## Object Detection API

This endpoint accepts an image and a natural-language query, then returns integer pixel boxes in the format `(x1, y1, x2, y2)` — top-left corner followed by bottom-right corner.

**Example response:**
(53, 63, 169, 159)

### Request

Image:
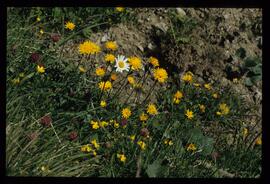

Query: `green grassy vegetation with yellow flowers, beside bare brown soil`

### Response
(6, 7, 261, 177)
